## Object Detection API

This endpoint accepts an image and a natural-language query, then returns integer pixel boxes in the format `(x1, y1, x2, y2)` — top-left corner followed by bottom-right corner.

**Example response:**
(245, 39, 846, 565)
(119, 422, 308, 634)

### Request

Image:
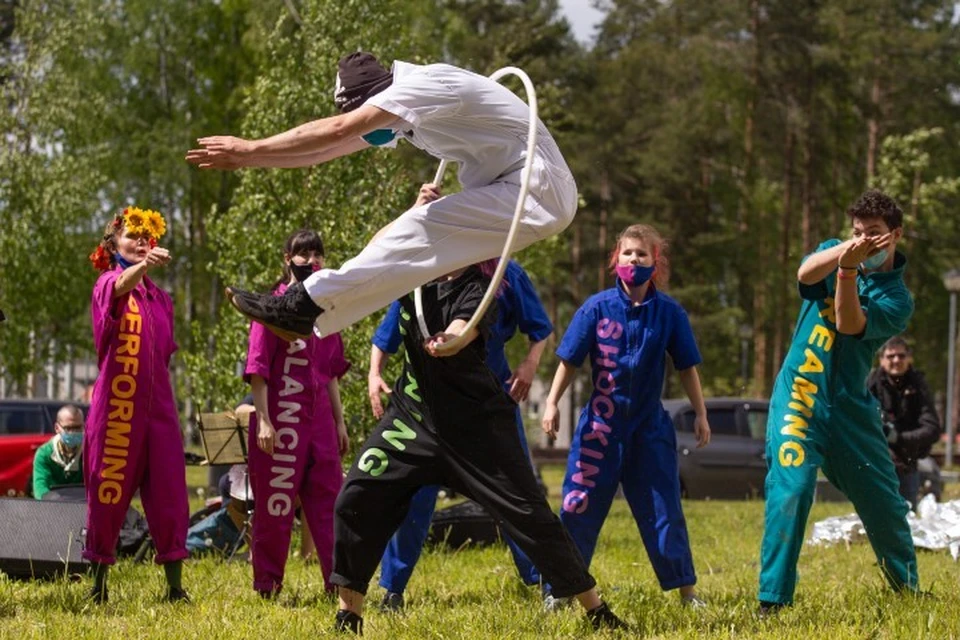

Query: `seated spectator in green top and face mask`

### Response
(33, 404, 83, 500)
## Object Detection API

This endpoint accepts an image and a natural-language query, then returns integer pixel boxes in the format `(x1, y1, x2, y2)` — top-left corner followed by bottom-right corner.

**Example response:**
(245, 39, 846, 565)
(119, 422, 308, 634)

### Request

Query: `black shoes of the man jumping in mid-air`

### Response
(227, 282, 323, 342)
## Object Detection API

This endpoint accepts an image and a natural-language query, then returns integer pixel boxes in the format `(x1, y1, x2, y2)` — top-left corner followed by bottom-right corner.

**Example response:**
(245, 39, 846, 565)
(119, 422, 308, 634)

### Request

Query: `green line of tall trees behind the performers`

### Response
(0, 0, 960, 440)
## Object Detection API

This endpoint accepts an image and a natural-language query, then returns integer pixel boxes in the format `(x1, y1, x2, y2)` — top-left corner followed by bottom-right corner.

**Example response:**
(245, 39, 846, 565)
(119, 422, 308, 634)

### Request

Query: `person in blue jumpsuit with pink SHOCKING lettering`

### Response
(543, 225, 710, 607)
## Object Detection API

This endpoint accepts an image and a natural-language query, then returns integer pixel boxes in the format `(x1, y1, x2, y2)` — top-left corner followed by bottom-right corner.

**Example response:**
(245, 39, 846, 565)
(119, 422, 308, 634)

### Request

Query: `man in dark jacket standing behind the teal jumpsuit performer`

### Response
(867, 336, 940, 508)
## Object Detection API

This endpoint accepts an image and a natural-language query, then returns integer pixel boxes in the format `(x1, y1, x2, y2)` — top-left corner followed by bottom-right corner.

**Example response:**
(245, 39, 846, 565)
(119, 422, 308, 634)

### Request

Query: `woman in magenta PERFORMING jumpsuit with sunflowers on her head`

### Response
(83, 207, 189, 603)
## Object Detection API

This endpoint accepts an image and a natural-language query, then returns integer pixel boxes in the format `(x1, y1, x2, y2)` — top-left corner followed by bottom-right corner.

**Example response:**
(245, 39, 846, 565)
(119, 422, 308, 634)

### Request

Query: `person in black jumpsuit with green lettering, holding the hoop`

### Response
(330, 265, 623, 633)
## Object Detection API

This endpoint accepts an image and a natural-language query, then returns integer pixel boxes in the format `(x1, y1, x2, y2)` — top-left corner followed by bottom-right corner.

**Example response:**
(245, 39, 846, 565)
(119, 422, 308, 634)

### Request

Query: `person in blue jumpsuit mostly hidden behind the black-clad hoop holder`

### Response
(368, 254, 553, 609)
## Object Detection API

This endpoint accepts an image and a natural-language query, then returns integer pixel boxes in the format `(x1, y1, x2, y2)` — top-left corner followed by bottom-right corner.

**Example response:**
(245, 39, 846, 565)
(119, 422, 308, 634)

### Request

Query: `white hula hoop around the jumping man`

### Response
(413, 67, 538, 354)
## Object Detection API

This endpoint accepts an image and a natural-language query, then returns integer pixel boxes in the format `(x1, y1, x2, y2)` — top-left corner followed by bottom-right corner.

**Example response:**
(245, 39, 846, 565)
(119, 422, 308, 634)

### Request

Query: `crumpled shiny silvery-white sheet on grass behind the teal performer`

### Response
(807, 495, 960, 560)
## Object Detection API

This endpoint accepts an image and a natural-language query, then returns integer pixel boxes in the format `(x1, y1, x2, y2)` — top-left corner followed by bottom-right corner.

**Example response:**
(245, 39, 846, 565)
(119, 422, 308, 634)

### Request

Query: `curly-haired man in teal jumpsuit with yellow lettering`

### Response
(759, 190, 917, 614)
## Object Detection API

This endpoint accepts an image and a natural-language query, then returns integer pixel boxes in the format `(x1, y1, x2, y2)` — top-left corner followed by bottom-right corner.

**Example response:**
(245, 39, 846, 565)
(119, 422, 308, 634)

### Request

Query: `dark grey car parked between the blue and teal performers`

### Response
(663, 398, 769, 500)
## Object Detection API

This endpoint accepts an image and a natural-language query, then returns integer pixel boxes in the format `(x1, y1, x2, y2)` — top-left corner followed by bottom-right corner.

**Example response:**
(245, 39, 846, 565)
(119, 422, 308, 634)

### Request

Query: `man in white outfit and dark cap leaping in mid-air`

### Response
(187, 52, 577, 339)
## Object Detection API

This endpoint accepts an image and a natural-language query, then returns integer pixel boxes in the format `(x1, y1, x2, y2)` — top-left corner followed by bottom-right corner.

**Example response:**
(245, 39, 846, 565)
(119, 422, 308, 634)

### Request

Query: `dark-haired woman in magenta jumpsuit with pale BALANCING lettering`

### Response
(245, 230, 350, 597)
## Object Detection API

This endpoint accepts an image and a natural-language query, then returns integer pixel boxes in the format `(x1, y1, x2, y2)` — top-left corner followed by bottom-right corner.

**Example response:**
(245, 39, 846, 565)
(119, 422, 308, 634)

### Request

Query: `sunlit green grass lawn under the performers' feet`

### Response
(0, 468, 960, 640)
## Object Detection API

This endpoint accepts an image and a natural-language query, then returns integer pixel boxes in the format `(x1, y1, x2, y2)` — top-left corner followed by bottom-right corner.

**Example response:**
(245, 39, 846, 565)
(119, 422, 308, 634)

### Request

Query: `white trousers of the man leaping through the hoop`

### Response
(304, 156, 577, 336)
